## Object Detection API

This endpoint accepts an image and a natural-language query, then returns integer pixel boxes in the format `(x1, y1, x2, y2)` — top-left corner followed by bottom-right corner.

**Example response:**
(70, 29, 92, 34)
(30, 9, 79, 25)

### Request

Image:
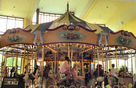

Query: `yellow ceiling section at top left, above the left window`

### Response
(0, 0, 40, 18)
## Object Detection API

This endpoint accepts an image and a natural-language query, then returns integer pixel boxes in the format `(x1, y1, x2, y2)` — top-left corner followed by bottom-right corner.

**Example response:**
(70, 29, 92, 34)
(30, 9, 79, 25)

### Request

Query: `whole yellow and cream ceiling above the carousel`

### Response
(0, 0, 136, 31)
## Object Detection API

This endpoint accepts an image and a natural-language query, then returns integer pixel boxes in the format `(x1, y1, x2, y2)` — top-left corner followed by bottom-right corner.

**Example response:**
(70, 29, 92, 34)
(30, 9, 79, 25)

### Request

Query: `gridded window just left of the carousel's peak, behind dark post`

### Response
(32, 12, 61, 24)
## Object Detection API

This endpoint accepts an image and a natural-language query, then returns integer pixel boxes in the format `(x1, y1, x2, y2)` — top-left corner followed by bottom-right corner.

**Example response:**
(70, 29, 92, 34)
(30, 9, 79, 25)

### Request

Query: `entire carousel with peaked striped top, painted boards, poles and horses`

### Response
(0, 2, 136, 88)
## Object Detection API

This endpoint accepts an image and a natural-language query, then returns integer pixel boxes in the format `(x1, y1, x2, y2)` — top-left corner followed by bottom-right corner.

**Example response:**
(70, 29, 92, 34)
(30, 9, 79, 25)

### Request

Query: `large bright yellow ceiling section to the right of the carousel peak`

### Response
(83, 0, 136, 31)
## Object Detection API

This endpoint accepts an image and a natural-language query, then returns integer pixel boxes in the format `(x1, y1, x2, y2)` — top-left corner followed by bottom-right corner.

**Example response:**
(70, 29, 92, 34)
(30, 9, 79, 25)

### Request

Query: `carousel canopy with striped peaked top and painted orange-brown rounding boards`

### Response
(0, 9, 136, 48)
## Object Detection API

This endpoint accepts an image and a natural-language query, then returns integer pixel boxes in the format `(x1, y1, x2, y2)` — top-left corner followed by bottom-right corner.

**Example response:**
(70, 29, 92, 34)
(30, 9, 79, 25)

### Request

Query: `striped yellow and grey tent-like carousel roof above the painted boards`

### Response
(25, 7, 112, 33)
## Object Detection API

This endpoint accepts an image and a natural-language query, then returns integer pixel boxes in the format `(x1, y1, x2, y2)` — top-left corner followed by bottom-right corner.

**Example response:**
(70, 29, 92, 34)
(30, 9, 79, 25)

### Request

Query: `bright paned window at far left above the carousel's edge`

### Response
(0, 16, 24, 34)
